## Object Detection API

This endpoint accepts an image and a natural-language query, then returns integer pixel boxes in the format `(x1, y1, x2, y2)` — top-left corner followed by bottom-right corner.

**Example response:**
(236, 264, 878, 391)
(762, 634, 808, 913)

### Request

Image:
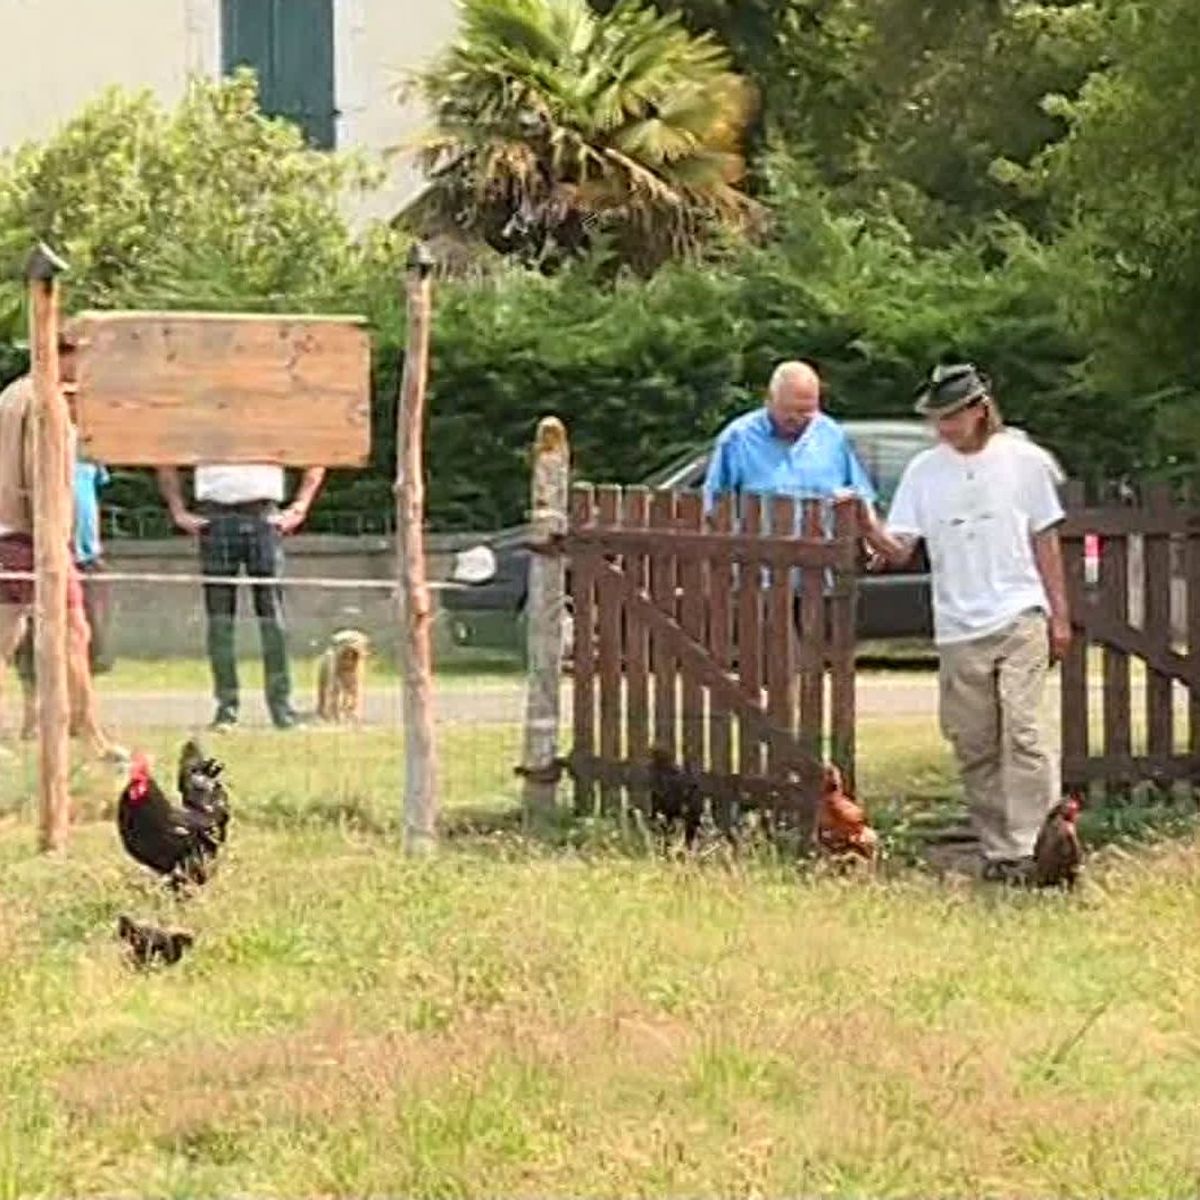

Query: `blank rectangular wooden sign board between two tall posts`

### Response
(71, 312, 371, 467)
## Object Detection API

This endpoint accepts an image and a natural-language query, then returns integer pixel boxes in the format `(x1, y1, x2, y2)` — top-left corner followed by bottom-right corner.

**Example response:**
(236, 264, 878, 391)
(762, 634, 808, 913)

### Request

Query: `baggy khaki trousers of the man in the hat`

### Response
(938, 611, 1057, 860)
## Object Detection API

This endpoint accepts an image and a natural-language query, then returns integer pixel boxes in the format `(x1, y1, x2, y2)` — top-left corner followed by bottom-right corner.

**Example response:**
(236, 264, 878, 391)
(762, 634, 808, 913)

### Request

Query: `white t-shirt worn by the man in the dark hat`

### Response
(888, 434, 1063, 646)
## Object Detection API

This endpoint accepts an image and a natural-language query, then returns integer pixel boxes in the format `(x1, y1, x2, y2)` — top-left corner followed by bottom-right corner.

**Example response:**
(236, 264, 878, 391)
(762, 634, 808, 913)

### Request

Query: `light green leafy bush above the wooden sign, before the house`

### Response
(0, 73, 396, 331)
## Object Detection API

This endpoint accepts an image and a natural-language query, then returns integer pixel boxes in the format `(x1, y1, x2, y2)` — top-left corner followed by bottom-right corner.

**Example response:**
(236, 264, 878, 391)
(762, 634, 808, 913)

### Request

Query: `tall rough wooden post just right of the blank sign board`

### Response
(395, 244, 437, 854)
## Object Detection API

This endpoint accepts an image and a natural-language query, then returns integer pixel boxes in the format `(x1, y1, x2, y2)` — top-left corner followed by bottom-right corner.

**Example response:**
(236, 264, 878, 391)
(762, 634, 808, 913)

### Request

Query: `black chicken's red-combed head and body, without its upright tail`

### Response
(116, 755, 218, 889)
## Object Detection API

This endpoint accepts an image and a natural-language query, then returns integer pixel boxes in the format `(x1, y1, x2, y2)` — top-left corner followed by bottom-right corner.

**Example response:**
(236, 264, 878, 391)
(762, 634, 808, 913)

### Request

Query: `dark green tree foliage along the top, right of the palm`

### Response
(614, 0, 1103, 244)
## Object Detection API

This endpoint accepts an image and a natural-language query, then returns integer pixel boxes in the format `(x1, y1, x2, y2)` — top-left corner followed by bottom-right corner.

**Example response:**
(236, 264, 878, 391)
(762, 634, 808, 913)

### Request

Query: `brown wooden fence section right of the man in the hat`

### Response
(1062, 484, 1200, 790)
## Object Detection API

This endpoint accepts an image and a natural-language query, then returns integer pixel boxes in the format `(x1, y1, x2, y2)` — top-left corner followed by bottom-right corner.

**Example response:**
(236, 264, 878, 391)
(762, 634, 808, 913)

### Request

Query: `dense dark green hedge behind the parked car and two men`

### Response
(0, 236, 1153, 529)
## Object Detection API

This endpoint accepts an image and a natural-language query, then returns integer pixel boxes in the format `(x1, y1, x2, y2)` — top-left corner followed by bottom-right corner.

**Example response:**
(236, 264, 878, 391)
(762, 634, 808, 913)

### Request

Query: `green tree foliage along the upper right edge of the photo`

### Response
(1039, 0, 1200, 457)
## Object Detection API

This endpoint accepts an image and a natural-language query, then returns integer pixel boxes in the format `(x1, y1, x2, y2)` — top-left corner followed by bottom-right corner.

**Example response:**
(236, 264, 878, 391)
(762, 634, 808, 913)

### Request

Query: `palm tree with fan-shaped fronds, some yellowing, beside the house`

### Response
(403, 0, 755, 270)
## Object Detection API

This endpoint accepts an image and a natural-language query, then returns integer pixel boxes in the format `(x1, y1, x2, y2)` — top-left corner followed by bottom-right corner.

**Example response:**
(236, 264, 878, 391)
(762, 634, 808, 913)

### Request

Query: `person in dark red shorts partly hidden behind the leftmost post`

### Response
(0, 336, 127, 763)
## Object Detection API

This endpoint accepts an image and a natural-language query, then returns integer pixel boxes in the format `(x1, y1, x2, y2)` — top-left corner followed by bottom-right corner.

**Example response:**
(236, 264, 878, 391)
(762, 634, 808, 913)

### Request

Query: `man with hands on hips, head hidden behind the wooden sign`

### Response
(158, 463, 325, 730)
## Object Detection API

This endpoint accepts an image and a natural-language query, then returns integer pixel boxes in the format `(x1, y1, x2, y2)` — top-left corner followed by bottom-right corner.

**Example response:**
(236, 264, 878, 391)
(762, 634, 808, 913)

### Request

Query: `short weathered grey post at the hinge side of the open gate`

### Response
(520, 416, 571, 816)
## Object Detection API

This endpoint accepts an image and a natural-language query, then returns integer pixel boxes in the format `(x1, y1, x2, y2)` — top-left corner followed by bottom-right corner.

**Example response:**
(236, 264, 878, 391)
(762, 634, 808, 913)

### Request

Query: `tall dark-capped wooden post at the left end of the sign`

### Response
(28, 245, 72, 851)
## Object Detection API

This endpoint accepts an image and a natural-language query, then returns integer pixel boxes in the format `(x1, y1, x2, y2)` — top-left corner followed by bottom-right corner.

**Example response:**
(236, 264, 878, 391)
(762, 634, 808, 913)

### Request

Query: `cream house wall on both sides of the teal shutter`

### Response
(0, 0, 456, 216)
